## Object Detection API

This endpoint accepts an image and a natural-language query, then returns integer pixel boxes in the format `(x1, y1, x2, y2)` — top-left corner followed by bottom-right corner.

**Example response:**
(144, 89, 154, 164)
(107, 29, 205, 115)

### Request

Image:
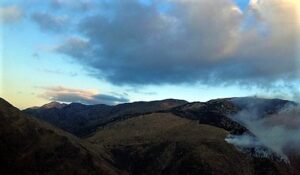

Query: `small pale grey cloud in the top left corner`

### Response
(0, 6, 22, 24)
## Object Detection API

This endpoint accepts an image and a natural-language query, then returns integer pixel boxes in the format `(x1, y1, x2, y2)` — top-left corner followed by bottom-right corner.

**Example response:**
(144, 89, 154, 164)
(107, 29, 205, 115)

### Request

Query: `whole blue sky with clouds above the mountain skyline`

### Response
(0, 0, 300, 109)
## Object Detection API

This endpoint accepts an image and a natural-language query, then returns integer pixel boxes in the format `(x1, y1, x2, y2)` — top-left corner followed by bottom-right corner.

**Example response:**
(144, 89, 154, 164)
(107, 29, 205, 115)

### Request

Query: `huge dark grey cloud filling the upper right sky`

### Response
(39, 0, 300, 87)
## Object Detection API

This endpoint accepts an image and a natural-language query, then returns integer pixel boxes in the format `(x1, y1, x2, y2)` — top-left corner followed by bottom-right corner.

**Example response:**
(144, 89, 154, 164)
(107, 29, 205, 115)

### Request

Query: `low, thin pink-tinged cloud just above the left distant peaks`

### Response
(41, 86, 129, 105)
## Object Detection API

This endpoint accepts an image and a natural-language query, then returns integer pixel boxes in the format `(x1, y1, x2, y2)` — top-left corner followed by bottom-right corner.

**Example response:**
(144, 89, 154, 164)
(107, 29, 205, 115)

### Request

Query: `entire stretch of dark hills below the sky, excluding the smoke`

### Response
(0, 97, 300, 175)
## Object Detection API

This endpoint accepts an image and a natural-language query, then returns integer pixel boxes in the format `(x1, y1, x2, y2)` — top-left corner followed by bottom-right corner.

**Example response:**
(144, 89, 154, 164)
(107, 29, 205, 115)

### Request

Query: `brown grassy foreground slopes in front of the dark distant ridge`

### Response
(0, 98, 291, 175)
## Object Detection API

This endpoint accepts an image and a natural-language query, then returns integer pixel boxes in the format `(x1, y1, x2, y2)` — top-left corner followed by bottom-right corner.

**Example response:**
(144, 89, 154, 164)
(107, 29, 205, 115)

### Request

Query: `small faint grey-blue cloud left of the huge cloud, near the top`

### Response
(31, 12, 70, 32)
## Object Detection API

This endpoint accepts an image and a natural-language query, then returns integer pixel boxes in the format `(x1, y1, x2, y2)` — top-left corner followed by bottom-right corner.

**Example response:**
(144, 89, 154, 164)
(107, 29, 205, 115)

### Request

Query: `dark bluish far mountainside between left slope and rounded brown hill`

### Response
(24, 99, 187, 136)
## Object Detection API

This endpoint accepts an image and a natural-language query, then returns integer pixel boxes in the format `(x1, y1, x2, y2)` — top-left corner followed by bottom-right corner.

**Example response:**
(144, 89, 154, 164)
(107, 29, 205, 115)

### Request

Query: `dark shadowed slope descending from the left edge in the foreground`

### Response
(0, 98, 118, 175)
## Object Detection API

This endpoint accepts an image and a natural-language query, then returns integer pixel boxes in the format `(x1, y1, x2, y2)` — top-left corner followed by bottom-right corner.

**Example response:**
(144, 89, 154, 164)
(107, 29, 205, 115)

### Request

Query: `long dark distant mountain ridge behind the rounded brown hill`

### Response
(23, 97, 296, 137)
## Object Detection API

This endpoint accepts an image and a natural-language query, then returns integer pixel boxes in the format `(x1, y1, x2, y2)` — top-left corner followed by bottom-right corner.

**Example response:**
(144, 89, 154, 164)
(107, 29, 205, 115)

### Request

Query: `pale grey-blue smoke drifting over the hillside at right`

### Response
(226, 100, 300, 161)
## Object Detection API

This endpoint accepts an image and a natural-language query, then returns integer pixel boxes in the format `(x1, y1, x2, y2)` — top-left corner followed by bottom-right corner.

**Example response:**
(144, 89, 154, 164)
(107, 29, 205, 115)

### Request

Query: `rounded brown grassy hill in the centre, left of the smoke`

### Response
(88, 113, 292, 175)
